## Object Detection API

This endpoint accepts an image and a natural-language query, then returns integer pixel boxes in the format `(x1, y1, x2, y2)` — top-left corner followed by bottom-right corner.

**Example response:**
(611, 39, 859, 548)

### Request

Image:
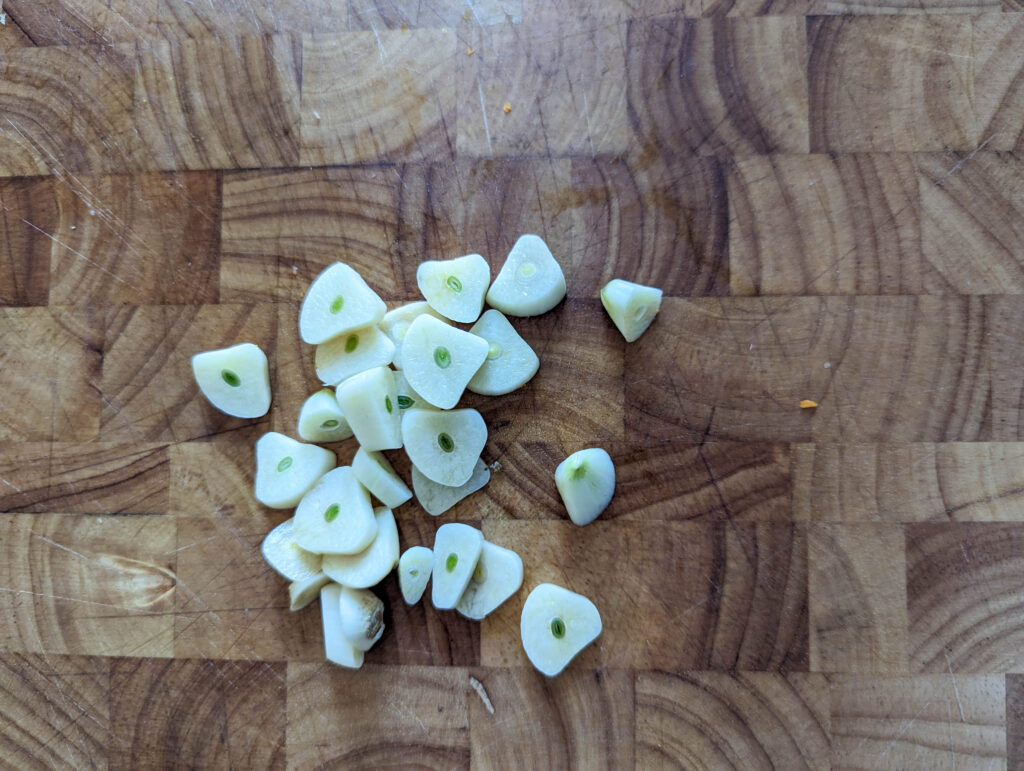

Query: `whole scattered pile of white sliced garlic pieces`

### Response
(193, 234, 662, 676)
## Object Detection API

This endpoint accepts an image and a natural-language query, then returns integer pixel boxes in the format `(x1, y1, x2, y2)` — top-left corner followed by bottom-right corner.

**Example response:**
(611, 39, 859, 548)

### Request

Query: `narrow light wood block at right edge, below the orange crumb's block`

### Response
(793, 442, 1024, 523)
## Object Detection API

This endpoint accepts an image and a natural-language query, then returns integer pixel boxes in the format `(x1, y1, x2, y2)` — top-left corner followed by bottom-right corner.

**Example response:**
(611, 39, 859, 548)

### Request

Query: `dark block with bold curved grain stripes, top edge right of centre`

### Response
(626, 16, 808, 158)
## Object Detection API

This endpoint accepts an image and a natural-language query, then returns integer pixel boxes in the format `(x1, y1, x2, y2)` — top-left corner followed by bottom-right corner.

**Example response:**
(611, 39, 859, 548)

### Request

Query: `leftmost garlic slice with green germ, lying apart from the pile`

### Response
(191, 343, 270, 418)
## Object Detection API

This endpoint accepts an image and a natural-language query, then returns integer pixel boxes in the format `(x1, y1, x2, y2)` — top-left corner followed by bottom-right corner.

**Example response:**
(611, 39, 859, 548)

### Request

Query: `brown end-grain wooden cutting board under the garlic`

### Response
(0, 0, 1024, 769)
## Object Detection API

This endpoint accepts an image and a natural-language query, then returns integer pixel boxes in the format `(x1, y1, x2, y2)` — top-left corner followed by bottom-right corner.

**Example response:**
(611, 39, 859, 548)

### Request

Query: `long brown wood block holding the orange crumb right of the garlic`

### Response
(625, 297, 995, 441)
